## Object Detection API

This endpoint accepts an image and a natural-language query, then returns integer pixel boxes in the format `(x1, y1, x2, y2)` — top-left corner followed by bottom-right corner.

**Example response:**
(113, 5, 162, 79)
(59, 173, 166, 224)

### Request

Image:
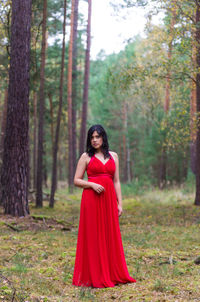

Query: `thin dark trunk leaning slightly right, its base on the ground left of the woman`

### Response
(49, 0, 67, 208)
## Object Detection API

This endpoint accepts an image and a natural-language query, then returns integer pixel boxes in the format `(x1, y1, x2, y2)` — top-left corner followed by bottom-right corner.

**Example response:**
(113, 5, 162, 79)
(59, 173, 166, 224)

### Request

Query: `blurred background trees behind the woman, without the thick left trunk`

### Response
(0, 0, 200, 214)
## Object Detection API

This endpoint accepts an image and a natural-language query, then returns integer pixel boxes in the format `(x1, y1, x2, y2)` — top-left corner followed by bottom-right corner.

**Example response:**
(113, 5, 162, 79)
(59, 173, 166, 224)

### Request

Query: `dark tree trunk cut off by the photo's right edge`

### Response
(194, 1, 200, 206)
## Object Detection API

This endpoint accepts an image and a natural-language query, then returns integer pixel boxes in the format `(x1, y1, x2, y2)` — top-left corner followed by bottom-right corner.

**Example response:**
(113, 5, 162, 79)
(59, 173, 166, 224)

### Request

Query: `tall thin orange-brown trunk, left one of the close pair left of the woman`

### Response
(67, 0, 75, 192)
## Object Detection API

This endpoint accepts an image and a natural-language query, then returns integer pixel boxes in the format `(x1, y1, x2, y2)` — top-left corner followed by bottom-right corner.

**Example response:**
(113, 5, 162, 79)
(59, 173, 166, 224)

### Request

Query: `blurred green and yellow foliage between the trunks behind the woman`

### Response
(0, 0, 197, 186)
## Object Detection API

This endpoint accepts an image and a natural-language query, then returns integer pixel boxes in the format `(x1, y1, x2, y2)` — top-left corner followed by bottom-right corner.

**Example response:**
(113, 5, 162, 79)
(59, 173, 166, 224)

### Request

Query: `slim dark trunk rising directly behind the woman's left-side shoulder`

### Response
(79, 0, 92, 155)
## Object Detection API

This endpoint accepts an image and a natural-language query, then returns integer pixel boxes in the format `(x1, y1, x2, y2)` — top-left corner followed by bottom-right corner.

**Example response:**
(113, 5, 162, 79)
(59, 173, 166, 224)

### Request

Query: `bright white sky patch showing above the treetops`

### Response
(79, 0, 155, 59)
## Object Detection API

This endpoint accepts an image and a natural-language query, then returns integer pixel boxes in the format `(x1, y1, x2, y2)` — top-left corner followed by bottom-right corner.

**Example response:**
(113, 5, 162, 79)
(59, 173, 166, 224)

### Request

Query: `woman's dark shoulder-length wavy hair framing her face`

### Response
(86, 125, 110, 158)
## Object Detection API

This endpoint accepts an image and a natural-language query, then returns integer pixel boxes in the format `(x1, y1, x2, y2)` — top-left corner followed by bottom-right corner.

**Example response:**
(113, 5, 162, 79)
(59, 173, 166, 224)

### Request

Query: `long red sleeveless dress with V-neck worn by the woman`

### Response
(73, 156, 136, 287)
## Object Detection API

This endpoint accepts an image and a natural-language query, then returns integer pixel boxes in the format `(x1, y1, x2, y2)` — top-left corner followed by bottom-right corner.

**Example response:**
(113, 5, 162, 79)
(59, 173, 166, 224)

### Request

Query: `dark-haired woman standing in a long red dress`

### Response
(73, 125, 136, 287)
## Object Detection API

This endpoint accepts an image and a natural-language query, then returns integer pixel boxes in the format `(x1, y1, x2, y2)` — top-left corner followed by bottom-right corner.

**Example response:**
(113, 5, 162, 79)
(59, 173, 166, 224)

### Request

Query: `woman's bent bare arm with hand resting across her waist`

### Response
(74, 153, 104, 193)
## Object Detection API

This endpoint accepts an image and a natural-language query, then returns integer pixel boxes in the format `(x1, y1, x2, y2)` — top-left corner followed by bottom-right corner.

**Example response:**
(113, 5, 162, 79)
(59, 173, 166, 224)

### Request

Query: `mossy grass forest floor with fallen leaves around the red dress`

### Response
(0, 184, 200, 302)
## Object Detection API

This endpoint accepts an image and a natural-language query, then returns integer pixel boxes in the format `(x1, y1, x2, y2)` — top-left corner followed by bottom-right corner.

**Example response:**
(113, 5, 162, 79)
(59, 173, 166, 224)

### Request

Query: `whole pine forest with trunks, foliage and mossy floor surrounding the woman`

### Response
(0, 0, 200, 302)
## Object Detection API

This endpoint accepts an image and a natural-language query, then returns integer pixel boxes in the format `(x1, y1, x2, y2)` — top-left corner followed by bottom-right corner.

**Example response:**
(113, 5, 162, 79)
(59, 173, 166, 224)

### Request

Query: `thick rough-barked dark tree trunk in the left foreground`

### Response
(1, 0, 31, 216)
